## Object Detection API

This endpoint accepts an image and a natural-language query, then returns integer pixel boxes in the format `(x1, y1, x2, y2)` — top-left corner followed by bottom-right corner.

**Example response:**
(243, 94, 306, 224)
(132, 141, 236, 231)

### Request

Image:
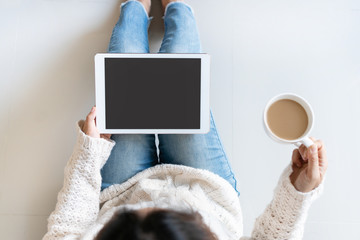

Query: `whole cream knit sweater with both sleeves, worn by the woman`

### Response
(43, 121, 323, 240)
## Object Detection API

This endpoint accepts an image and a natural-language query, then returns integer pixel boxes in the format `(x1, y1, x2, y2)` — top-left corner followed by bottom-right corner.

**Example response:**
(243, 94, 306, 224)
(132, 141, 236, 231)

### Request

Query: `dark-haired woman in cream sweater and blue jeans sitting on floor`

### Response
(44, 0, 327, 240)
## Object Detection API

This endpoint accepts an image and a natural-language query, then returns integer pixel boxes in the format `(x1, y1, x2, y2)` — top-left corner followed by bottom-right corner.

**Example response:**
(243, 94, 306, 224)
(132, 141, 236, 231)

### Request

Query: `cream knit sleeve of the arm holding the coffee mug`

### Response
(241, 166, 323, 240)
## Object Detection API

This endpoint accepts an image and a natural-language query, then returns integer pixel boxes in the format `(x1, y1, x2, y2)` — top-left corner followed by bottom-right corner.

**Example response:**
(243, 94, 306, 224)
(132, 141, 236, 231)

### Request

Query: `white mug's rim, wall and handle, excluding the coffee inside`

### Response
(264, 93, 314, 147)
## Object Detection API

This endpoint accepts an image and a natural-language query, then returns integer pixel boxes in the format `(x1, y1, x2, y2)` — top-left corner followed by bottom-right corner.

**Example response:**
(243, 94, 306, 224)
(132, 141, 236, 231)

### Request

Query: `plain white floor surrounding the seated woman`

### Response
(0, 0, 360, 240)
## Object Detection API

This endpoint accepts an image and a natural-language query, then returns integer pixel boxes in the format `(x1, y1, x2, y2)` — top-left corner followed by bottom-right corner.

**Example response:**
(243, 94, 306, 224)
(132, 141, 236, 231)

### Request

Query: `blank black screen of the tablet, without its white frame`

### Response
(105, 58, 201, 129)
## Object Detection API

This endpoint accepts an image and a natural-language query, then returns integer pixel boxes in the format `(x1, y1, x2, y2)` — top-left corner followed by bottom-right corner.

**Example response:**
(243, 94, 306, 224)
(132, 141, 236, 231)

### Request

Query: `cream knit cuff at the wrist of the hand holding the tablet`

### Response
(76, 120, 115, 166)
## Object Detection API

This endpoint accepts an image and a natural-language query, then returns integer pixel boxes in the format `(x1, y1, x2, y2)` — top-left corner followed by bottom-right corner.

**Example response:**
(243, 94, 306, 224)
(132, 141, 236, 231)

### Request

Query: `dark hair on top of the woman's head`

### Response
(96, 210, 217, 240)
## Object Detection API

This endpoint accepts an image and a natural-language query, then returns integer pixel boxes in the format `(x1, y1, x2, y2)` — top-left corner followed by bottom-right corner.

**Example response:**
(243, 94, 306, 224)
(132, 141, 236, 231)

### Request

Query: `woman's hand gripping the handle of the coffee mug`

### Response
(290, 138, 328, 192)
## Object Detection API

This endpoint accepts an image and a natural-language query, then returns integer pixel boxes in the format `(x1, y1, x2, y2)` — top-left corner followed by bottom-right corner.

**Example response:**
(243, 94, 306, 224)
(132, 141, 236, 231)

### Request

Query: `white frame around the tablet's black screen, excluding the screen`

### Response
(95, 53, 210, 134)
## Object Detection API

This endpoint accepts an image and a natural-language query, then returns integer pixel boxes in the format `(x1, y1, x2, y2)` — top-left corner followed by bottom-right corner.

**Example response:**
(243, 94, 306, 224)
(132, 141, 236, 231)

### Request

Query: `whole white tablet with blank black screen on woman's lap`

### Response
(95, 53, 210, 134)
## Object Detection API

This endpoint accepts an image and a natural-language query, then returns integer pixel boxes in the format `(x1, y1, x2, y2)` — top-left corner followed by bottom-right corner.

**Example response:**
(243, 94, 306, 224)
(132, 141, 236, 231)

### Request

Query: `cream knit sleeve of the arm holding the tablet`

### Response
(43, 121, 115, 240)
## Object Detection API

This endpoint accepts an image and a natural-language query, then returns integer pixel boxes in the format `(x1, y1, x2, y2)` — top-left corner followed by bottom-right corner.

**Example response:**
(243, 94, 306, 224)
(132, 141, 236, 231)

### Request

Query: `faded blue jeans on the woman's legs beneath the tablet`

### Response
(101, 0, 239, 194)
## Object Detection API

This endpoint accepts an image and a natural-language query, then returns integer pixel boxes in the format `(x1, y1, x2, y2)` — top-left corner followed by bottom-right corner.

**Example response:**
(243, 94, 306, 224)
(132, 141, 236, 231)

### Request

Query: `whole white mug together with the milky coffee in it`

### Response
(264, 93, 314, 147)
